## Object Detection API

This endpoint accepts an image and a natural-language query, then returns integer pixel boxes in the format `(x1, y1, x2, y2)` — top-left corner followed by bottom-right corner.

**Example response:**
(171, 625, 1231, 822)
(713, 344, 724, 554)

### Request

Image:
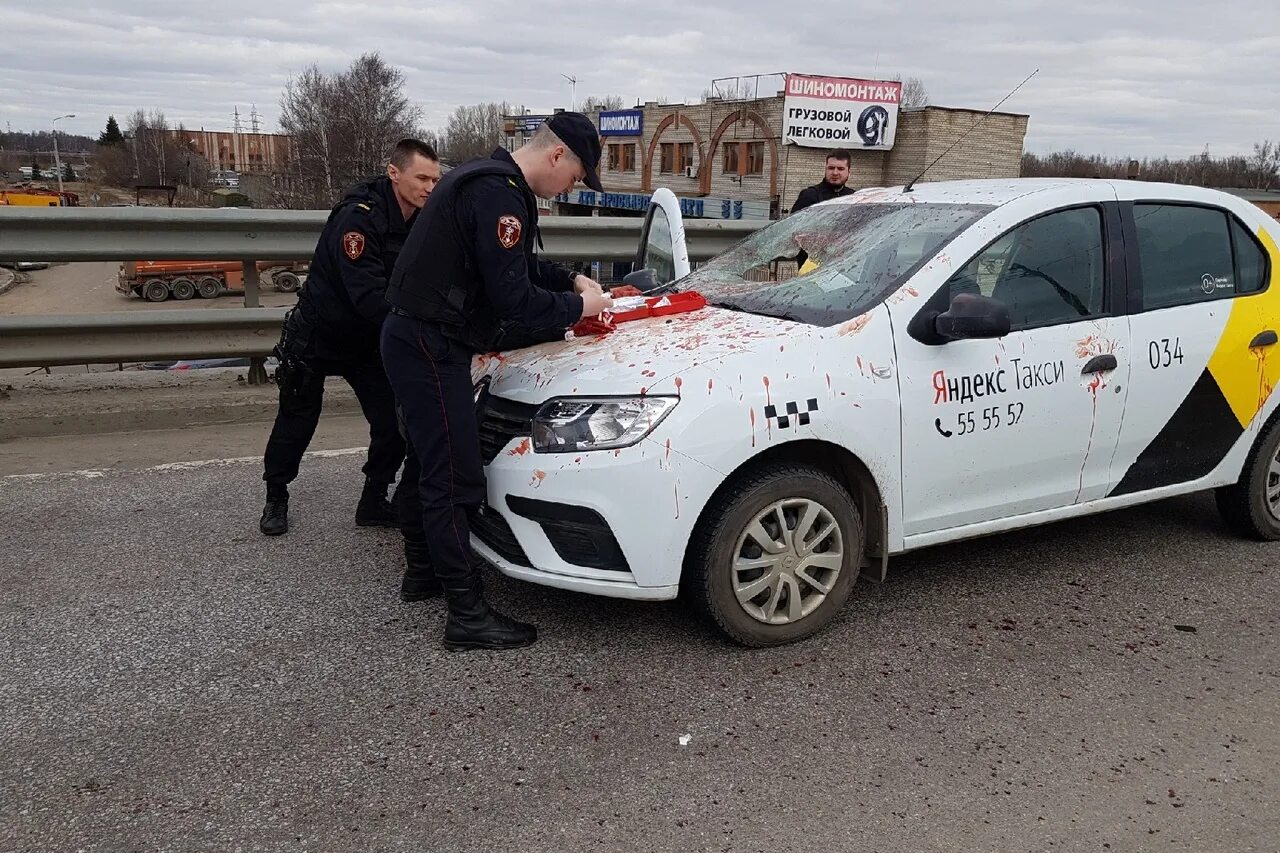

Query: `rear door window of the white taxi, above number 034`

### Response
(1133, 204, 1248, 310)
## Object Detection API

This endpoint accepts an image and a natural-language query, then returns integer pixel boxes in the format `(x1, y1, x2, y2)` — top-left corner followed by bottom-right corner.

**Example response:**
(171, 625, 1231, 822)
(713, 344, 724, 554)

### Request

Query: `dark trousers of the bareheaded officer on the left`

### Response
(262, 356, 404, 485)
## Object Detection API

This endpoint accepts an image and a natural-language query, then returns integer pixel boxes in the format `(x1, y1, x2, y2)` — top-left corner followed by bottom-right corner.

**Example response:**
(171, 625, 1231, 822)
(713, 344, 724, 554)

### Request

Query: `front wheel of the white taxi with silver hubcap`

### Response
(682, 462, 864, 648)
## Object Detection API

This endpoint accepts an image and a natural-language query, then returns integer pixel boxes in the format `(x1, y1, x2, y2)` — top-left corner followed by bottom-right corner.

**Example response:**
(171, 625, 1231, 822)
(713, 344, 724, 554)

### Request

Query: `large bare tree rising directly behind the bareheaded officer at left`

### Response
(273, 54, 422, 207)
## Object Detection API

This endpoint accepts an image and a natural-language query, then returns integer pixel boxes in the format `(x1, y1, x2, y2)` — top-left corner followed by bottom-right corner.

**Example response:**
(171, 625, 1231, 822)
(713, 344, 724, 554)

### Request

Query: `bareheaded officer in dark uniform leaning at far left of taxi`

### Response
(259, 140, 440, 535)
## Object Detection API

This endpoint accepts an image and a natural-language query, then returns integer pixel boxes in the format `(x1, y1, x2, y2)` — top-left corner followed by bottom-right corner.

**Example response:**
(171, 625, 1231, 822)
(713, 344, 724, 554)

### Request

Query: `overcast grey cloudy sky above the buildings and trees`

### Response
(0, 0, 1280, 156)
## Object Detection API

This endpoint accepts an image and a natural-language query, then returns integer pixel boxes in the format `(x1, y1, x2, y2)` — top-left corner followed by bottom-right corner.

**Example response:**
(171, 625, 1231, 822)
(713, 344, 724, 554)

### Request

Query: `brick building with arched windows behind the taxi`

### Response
(547, 85, 1028, 219)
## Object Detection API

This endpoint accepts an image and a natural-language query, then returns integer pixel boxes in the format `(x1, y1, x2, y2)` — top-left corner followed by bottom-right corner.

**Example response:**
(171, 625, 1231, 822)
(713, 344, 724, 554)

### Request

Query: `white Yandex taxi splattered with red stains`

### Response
(472, 179, 1280, 646)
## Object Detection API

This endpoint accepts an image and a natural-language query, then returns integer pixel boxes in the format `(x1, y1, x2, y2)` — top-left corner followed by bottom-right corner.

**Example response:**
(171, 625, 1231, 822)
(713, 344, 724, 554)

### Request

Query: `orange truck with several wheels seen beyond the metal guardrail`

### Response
(115, 261, 307, 302)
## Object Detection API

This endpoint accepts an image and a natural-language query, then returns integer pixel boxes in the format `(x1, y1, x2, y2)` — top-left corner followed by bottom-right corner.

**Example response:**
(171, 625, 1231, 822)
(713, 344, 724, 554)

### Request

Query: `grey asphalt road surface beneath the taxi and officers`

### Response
(0, 440, 1280, 853)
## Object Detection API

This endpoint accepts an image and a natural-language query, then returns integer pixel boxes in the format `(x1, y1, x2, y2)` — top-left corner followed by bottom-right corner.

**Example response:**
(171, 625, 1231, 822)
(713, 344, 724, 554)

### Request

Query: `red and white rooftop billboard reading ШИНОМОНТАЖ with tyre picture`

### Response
(782, 74, 902, 151)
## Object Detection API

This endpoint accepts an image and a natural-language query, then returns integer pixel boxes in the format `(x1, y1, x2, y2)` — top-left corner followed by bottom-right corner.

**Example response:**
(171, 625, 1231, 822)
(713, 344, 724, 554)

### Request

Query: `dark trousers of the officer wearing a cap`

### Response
(383, 311, 485, 587)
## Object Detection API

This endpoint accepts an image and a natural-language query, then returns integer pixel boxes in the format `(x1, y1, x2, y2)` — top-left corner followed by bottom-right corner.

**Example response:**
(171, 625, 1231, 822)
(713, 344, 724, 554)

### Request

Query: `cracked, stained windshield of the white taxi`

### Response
(676, 202, 993, 325)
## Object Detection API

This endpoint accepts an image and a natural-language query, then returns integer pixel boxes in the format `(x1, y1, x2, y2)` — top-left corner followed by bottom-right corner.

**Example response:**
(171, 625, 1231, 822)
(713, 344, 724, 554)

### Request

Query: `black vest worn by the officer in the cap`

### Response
(387, 158, 541, 352)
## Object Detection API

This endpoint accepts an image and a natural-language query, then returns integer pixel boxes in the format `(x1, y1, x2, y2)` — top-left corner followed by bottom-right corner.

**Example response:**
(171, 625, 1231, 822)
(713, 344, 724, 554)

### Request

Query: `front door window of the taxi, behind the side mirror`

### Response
(948, 207, 1106, 329)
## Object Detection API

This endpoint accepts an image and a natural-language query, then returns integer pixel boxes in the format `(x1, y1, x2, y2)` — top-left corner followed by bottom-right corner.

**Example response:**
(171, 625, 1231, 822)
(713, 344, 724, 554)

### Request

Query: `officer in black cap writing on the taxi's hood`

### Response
(383, 113, 611, 649)
